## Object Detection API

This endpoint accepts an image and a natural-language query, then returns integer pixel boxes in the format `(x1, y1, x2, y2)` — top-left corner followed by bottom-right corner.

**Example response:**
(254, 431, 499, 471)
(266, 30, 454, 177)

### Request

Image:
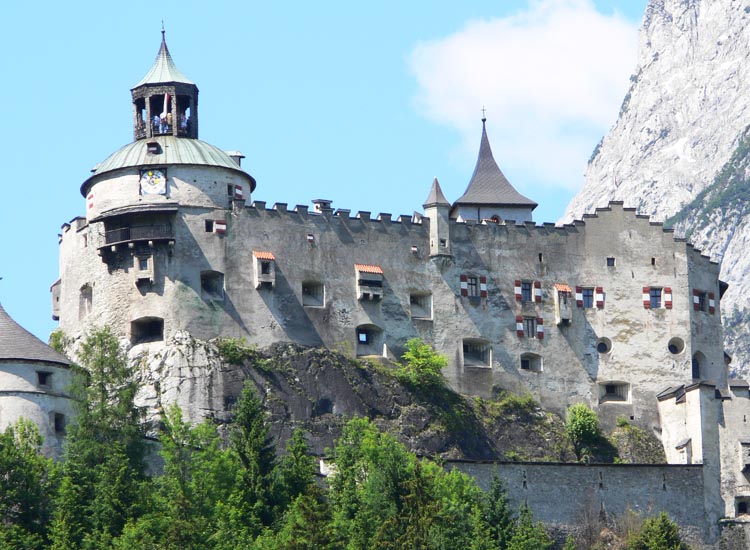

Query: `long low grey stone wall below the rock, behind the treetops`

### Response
(446, 461, 718, 548)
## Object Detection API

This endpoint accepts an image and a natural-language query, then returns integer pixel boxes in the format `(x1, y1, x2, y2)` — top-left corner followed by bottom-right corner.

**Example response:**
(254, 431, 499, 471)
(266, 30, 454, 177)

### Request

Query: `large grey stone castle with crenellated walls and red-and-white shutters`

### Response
(0, 32, 750, 538)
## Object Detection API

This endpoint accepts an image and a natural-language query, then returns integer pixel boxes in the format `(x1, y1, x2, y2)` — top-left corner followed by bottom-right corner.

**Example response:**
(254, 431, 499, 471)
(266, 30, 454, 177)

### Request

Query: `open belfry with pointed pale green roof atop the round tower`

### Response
(130, 29, 198, 141)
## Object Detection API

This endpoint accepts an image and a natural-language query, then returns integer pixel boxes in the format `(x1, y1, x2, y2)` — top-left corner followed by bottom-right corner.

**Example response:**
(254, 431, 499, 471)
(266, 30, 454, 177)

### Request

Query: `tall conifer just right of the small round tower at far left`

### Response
(51, 328, 146, 548)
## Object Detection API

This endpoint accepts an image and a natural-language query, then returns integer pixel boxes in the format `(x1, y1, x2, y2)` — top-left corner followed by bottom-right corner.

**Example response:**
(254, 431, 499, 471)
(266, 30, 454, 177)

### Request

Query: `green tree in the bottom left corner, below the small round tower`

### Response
(0, 419, 57, 548)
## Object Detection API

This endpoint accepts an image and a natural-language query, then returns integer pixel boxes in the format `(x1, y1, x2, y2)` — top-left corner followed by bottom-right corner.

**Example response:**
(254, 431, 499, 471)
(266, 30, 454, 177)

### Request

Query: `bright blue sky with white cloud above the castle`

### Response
(0, 0, 647, 340)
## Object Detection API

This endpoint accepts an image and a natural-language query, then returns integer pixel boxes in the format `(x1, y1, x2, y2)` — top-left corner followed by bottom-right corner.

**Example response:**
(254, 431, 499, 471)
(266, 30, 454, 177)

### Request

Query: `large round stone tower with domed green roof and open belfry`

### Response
(52, 31, 255, 344)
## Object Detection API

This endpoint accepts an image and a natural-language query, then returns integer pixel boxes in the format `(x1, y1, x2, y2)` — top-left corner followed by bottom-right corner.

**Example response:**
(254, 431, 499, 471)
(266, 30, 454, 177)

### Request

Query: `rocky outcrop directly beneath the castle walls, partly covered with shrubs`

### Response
(129, 331, 575, 461)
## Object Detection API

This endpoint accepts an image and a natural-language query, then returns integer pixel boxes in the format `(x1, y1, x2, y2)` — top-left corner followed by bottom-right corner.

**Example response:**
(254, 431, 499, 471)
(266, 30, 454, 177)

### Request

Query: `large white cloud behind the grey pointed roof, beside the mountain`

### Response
(409, 0, 638, 189)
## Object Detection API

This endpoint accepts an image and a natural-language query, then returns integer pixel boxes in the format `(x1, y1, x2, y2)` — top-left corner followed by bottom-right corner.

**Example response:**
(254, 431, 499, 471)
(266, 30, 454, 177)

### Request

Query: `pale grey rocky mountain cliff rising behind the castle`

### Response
(564, 0, 750, 376)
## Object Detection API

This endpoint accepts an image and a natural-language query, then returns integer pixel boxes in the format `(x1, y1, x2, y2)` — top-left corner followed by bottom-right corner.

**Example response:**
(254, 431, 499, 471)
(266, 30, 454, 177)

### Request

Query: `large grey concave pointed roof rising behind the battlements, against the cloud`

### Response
(453, 120, 537, 210)
